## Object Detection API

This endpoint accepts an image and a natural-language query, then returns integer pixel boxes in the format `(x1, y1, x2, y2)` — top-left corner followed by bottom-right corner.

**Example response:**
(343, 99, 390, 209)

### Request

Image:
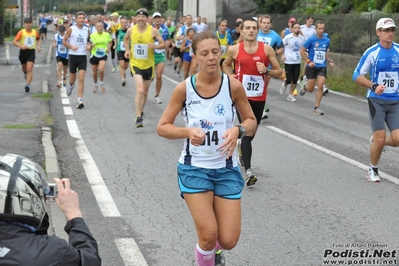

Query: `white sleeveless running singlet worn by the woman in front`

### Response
(179, 74, 237, 169)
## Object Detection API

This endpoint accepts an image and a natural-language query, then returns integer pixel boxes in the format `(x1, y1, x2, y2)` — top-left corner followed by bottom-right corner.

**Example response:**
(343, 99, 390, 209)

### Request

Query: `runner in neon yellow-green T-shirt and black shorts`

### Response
(90, 21, 112, 93)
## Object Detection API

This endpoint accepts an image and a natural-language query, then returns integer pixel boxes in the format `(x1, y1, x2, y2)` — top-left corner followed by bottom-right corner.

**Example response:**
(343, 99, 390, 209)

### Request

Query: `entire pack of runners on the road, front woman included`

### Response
(10, 8, 399, 266)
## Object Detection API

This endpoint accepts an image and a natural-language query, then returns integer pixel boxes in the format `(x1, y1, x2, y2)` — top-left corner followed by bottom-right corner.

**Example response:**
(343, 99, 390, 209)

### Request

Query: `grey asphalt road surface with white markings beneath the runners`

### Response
(49, 54, 399, 266)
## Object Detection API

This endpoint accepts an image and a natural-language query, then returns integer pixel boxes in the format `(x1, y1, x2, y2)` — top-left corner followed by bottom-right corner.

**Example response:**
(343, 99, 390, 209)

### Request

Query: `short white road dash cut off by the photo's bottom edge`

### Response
(115, 238, 148, 266)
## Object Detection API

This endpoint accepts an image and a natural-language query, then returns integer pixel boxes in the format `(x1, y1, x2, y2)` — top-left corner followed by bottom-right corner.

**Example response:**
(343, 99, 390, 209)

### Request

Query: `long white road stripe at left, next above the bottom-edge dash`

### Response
(67, 120, 121, 217)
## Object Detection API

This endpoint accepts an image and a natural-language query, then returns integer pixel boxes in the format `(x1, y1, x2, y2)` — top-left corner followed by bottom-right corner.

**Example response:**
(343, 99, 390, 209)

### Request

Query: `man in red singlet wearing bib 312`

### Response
(222, 19, 283, 186)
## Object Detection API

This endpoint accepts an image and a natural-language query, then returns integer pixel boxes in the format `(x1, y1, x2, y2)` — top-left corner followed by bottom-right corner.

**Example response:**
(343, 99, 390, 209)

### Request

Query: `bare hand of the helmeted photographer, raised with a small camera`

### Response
(54, 178, 82, 221)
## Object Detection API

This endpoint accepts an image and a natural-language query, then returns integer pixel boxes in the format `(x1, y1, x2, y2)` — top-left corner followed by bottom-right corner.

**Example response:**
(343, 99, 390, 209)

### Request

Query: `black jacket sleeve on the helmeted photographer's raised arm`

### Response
(60, 218, 101, 266)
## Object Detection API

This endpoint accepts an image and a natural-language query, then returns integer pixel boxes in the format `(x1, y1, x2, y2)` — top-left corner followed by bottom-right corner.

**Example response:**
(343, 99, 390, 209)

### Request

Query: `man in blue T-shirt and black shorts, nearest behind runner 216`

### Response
(299, 20, 334, 115)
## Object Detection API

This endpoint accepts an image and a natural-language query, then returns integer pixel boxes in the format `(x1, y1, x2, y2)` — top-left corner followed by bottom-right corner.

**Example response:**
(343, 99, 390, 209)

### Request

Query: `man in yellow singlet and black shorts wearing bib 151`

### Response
(123, 8, 166, 128)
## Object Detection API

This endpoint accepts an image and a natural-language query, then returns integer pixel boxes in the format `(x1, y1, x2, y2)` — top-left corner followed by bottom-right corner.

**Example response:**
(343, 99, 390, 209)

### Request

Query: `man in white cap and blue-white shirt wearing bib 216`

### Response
(352, 18, 399, 182)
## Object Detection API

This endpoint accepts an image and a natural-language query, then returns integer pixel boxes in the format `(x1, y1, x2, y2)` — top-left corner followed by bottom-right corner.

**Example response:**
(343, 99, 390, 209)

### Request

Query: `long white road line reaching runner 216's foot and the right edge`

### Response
(265, 126, 399, 185)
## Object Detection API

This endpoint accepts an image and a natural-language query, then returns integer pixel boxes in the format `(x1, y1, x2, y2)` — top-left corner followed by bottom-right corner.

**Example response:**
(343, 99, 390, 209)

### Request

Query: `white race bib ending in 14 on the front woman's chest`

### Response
(190, 116, 226, 156)
